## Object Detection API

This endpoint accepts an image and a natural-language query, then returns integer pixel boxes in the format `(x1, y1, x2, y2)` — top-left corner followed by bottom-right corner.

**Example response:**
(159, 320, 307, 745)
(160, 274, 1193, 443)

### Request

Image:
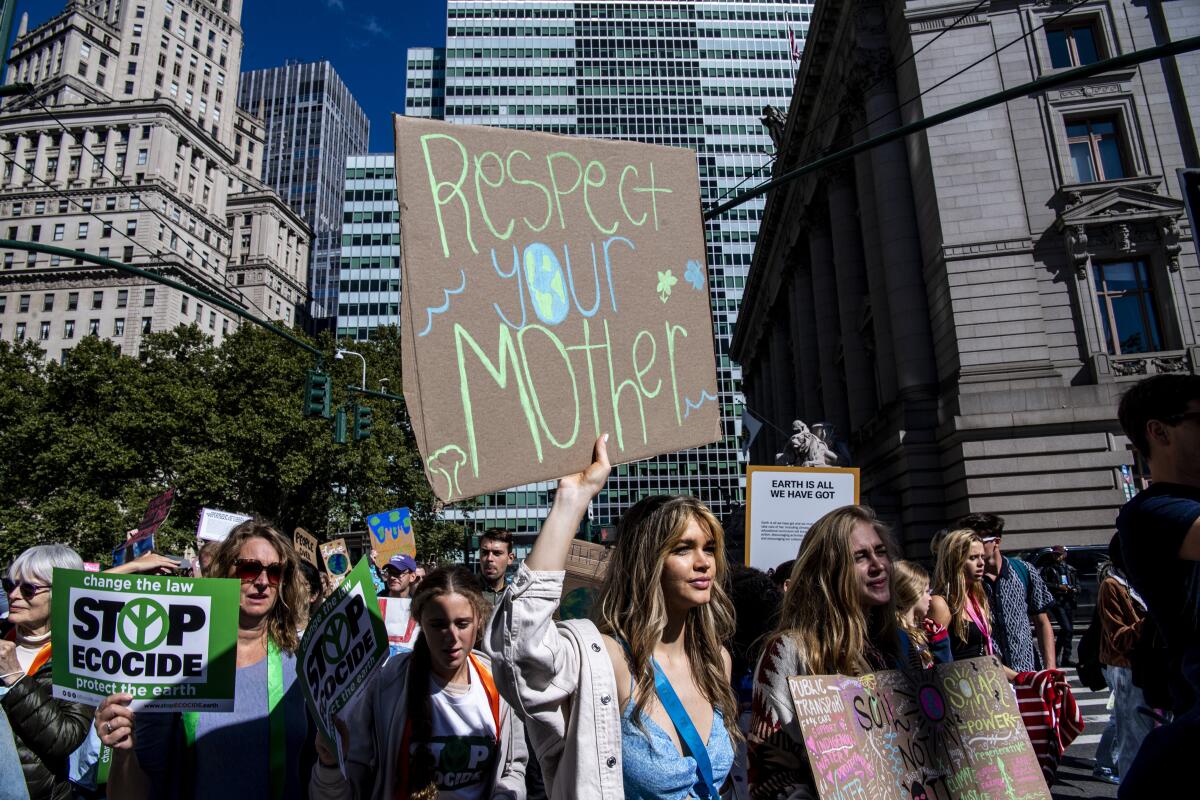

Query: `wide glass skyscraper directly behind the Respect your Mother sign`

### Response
(393, 0, 812, 530)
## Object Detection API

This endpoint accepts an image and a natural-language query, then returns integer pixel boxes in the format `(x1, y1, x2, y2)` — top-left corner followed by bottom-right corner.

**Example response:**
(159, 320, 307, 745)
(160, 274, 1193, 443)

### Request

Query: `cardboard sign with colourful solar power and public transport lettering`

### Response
(788, 656, 1050, 800)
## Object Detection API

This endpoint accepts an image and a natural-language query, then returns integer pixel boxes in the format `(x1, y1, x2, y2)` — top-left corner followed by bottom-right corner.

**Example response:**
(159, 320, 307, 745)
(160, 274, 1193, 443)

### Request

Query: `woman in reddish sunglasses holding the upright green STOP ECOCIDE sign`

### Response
(96, 518, 310, 800)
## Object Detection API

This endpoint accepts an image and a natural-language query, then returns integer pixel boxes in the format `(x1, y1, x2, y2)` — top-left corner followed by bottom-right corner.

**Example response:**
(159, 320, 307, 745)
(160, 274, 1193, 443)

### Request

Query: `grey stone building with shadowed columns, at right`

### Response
(732, 0, 1200, 555)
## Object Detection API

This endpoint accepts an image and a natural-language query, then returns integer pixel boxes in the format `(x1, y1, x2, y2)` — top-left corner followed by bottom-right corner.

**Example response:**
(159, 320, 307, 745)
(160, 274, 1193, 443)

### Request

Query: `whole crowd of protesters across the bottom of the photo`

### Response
(0, 377, 1200, 800)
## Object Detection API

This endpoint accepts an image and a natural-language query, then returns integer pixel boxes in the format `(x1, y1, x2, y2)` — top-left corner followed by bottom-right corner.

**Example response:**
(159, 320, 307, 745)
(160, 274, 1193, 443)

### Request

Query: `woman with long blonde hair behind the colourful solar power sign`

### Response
(749, 505, 912, 800)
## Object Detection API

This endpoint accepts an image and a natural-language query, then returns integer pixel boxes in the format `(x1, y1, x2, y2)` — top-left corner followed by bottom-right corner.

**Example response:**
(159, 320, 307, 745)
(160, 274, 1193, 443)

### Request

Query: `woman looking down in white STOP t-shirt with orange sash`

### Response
(310, 566, 526, 800)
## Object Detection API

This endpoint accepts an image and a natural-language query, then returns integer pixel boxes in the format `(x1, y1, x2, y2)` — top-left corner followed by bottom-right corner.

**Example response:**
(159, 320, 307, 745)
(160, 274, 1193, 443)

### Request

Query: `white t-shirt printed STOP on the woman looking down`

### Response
(414, 664, 498, 800)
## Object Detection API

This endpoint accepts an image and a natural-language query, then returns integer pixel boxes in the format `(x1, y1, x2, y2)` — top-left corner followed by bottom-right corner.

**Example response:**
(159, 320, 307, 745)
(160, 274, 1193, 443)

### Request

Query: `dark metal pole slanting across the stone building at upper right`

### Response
(704, 36, 1200, 222)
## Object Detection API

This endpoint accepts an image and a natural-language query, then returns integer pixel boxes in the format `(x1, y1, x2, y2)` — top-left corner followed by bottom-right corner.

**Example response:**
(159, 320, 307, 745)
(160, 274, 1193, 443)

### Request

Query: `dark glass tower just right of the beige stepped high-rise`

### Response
(238, 61, 371, 329)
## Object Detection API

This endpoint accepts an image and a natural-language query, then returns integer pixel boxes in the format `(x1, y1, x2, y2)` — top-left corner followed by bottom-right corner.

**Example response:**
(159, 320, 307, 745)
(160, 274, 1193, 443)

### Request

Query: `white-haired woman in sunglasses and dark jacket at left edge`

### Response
(0, 545, 91, 800)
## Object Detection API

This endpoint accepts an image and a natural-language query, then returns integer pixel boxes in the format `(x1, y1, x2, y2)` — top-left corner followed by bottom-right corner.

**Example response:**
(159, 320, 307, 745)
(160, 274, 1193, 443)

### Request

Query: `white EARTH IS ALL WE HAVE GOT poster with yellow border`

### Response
(746, 465, 858, 571)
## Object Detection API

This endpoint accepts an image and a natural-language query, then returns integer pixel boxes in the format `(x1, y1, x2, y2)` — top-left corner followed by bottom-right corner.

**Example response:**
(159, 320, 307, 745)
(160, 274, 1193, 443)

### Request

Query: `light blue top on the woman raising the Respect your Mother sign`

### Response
(620, 697, 733, 800)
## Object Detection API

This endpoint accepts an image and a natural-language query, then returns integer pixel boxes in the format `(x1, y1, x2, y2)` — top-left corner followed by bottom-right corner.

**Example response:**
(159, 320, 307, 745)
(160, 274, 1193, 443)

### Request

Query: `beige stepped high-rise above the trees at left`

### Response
(0, 0, 311, 359)
